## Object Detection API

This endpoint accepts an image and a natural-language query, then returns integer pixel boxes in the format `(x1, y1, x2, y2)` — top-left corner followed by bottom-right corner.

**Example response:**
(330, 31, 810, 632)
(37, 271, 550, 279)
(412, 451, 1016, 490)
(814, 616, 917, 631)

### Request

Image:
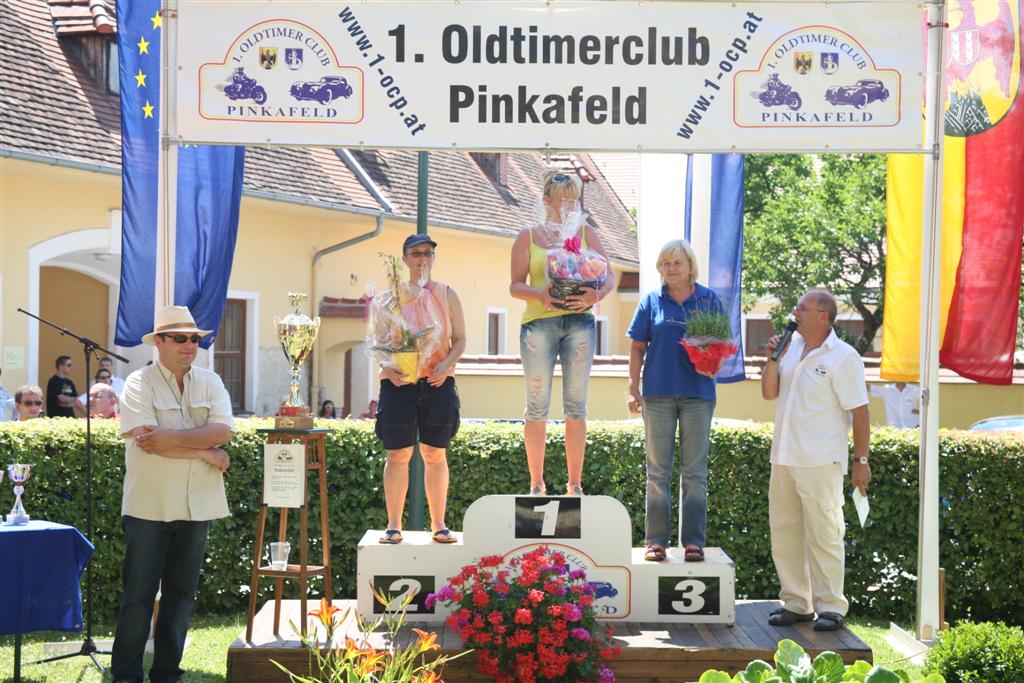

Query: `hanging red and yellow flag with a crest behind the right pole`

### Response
(881, 0, 1024, 384)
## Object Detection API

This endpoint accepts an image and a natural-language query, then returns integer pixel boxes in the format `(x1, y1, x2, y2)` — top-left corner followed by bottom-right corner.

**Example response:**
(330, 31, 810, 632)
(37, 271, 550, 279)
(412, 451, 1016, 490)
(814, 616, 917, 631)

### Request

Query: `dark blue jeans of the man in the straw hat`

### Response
(111, 516, 210, 683)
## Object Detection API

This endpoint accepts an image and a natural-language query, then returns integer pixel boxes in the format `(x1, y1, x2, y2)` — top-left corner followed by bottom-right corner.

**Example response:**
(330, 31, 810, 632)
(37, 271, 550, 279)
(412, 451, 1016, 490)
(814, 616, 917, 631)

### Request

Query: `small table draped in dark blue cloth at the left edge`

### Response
(0, 521, 93, 680)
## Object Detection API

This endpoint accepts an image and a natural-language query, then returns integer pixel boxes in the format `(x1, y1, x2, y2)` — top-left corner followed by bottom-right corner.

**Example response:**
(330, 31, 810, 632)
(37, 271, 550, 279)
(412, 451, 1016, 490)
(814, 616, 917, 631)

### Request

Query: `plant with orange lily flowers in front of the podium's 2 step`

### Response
(271, 591, 464, 683)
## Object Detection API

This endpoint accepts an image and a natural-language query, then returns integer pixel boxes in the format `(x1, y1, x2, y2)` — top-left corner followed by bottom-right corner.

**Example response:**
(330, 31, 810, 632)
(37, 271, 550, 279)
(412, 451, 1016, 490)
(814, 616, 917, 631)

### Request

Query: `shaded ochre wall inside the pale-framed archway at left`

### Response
(39, 267, 109, 393)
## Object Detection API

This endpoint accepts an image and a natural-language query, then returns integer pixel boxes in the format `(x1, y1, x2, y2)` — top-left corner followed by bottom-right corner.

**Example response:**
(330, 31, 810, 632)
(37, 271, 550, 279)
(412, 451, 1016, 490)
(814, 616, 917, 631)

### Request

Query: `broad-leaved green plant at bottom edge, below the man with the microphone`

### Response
(697, 640, 945, 683)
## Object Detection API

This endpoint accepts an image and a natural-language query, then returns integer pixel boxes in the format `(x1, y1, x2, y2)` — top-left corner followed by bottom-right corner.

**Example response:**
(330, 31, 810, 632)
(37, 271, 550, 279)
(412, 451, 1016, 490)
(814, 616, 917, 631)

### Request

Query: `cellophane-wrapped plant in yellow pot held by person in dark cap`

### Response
(366, 254, 441, 382)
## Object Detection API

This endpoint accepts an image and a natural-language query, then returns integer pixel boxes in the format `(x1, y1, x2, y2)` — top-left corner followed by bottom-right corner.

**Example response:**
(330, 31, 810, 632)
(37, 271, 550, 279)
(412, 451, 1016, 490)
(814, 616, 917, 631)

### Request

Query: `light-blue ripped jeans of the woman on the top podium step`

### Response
(519, 313, 597, 421)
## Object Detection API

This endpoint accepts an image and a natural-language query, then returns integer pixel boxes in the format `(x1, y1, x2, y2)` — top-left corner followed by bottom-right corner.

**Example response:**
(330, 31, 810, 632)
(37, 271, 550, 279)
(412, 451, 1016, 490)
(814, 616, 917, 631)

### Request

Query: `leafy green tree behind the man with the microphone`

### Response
(743, 155, 886, 353)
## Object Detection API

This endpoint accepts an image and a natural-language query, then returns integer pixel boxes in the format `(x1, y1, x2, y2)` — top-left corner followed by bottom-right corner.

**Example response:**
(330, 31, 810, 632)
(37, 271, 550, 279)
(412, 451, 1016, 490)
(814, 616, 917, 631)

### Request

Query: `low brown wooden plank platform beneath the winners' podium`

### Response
(226, 600, 871, 683)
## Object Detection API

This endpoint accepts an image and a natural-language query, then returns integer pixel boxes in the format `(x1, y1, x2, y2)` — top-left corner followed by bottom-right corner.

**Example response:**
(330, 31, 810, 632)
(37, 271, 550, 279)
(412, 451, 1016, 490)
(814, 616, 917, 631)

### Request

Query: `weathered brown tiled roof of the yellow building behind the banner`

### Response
(0, 0, 637, 263)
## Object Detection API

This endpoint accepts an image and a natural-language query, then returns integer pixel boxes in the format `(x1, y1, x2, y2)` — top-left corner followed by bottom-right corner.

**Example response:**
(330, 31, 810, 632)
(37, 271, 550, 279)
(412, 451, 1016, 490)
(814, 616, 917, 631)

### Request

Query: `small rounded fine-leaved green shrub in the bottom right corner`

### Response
(925, 622, 1024, 683)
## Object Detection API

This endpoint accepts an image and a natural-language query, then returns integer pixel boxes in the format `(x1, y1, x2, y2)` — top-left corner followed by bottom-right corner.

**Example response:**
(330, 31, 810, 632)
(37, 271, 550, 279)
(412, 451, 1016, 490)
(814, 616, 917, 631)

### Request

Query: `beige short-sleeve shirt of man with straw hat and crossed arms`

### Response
(121, 361, 234, 521)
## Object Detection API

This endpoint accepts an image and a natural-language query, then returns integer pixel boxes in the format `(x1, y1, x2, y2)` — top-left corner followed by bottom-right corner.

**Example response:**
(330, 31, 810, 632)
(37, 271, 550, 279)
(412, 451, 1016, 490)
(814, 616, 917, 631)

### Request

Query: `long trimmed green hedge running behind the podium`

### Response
(0, 419, 1024, 624)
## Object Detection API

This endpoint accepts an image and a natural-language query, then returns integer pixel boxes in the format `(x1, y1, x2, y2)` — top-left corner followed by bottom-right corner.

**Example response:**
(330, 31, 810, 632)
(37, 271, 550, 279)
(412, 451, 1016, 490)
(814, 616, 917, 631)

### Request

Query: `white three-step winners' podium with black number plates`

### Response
(356, 496, 736, 625)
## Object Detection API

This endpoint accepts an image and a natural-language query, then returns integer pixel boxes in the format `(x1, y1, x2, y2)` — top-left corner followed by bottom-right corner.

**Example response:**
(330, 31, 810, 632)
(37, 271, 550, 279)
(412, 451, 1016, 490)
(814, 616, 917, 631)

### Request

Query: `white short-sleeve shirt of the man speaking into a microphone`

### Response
(771, 330, 867, 473)
